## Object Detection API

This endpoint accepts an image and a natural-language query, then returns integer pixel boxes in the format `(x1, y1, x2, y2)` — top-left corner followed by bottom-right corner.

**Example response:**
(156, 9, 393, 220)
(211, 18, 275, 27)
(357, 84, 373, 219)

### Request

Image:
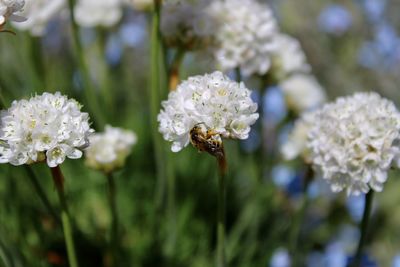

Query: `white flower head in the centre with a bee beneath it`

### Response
(158, 72, 259, 152)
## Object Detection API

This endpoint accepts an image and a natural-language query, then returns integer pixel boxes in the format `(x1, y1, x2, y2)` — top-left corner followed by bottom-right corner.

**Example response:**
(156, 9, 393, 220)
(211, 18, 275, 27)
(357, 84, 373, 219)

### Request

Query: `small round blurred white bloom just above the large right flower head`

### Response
(280, 74, 326, 113)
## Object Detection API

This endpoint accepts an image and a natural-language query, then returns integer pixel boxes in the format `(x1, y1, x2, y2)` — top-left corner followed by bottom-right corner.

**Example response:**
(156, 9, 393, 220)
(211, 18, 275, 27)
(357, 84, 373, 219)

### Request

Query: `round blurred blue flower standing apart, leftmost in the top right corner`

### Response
(318, 4, 353, 35)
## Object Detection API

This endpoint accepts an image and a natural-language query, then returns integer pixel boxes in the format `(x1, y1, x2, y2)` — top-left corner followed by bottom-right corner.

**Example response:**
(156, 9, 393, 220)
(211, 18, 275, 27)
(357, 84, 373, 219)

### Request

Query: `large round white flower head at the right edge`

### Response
(308, 93, 400, 195)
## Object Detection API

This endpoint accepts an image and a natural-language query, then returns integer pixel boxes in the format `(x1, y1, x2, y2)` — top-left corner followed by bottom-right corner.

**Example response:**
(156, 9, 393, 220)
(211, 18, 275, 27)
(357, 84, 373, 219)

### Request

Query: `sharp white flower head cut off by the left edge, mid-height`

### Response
(0, 92, 93, 167)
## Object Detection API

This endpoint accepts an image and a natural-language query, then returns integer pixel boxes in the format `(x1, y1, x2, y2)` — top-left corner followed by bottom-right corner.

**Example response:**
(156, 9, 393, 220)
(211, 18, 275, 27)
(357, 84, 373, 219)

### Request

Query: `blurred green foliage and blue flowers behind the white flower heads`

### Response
(0, 0, 400, 267)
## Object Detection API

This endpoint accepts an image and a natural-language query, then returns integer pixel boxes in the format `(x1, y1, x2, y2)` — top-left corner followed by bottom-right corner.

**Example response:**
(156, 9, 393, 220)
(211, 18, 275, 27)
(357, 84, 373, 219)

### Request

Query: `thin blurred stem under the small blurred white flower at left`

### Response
(107, 173, 119, 266)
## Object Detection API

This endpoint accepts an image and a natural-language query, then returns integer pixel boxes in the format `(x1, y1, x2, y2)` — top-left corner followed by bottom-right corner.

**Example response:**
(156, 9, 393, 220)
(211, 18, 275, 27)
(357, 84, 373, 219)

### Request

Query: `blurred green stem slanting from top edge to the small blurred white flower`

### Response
(68, 0, 104, 128)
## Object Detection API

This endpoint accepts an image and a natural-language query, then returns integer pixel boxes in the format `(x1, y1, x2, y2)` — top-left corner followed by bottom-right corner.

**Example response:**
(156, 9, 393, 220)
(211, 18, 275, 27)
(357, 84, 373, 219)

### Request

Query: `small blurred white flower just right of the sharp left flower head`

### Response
(85, 125, 137, 173)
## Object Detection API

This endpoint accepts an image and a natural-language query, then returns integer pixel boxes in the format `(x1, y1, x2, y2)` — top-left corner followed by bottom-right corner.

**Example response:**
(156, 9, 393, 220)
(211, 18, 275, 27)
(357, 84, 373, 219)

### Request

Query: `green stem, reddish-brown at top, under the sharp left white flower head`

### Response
(50, 166, 78, 267)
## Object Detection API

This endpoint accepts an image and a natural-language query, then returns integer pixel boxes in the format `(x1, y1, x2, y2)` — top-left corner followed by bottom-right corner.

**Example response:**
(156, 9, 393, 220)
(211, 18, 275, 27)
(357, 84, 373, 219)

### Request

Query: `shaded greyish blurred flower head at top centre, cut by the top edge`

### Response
(161, 0, 213, 50)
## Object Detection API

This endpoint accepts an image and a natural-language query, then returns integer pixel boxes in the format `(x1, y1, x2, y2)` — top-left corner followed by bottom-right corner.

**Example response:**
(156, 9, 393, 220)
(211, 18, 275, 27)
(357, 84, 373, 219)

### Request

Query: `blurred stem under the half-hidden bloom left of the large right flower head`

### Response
(289, 165, 314, 266)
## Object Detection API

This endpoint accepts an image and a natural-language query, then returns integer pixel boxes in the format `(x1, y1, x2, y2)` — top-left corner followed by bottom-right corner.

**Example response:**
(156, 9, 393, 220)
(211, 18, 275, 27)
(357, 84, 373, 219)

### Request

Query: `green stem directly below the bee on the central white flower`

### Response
(217, 155, 226, 267)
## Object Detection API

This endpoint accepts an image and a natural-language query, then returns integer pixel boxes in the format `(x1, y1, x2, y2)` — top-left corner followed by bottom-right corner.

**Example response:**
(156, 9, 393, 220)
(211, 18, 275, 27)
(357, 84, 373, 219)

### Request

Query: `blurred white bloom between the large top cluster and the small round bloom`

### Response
(272, 34, 311, 78)
